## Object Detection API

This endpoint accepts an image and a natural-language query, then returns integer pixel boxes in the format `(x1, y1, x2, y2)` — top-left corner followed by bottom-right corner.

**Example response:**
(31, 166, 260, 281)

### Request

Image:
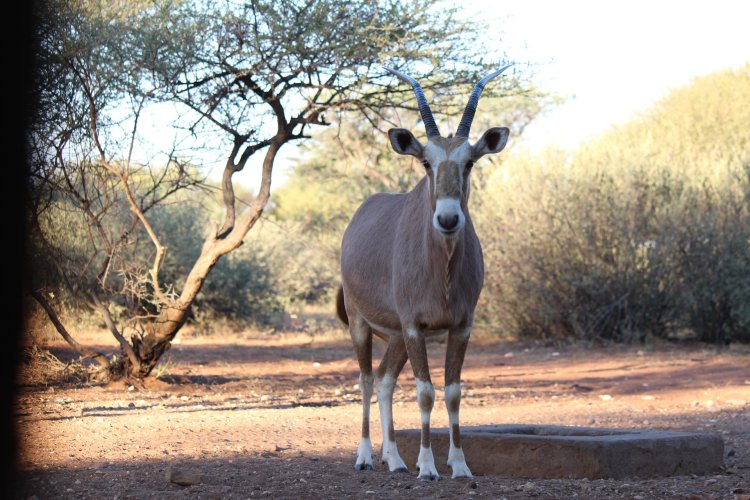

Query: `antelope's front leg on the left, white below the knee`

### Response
(404, 327, 440, 481)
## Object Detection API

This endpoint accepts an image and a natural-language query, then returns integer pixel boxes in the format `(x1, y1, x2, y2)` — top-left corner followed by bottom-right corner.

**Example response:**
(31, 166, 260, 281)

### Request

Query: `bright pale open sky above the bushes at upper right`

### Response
(488, 0, 750, 149)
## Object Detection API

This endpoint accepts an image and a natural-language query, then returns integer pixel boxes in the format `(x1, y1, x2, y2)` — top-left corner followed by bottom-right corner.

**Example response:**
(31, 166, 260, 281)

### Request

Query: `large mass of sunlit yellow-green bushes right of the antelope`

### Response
(479, 67, 750, 341)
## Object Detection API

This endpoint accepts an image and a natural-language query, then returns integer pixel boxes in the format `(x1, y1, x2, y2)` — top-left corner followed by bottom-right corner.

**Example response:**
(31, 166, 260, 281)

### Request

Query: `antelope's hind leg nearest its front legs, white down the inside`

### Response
(377, 337, 409, 472)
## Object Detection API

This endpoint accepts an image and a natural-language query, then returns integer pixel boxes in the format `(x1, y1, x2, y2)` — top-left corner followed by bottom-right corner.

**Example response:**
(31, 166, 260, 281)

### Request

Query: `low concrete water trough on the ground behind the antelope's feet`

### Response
(396, 425, 724, 479)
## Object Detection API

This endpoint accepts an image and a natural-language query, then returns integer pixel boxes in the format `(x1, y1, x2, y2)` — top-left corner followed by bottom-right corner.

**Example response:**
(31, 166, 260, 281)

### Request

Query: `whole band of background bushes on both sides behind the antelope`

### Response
(32, 66, 750, 342)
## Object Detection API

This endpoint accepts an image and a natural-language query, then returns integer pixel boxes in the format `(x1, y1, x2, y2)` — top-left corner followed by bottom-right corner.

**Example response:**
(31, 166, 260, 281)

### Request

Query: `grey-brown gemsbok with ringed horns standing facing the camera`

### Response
(337, 66, 509, 480)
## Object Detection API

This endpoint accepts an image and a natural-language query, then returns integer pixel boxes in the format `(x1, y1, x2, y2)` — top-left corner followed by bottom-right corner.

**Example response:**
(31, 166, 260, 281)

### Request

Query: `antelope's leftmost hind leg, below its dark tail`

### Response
(349, 314, 373, 470)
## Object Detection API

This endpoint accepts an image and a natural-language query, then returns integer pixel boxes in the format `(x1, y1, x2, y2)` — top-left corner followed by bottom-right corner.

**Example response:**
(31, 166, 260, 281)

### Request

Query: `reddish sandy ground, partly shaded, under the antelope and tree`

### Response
(11, 332, 750, 500)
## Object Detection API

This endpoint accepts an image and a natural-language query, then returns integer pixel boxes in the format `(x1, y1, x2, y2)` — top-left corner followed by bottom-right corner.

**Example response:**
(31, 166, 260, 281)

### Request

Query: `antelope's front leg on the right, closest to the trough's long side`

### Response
(445, 326, 472, 479)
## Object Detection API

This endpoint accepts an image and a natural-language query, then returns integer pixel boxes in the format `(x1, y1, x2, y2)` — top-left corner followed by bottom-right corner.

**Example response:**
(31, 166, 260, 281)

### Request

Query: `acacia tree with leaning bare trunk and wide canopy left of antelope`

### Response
(32, 0, 536, 378)
